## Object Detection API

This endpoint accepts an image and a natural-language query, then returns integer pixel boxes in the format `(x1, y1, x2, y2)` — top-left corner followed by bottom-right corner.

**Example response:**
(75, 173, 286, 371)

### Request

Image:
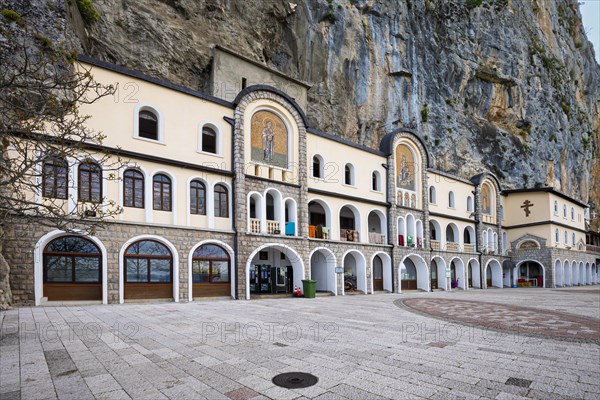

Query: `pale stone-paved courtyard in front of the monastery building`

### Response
(0, 286, 600, 400)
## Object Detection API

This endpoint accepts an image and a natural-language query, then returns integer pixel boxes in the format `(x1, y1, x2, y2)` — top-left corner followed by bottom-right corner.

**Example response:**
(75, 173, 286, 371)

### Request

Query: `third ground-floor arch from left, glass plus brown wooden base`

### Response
(191, 243, 232, 297)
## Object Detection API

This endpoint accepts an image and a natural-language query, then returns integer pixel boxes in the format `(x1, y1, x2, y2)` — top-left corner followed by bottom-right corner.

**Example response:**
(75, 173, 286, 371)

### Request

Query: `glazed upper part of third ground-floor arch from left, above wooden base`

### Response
(192, 244, 230, 284)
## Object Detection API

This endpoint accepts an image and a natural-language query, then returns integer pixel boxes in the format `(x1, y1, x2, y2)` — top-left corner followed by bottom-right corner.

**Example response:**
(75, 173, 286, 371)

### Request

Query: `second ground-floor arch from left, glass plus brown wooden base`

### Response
(123, 239, 174, 300)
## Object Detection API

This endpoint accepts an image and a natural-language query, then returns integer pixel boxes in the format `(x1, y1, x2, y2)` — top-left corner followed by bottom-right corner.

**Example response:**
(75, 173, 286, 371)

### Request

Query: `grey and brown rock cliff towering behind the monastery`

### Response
(4, 0, 600, 216)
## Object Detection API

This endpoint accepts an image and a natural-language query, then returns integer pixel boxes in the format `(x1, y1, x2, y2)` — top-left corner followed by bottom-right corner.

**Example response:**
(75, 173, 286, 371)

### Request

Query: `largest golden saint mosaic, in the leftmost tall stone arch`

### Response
(251, 111, 288, 168)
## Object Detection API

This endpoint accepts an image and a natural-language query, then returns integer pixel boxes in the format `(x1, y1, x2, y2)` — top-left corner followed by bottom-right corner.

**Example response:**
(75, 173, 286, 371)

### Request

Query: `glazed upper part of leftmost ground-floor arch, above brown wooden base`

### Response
(44, 236, 102, 284)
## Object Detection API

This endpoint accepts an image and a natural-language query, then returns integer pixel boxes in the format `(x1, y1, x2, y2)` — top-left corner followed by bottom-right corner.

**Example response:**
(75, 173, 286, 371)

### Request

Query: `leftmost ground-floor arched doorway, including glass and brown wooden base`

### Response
(43, 236, 103, 301)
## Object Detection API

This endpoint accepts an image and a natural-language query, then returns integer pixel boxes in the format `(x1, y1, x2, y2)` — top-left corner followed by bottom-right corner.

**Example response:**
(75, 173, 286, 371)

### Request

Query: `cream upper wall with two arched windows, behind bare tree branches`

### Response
(81, 64, 233, 170)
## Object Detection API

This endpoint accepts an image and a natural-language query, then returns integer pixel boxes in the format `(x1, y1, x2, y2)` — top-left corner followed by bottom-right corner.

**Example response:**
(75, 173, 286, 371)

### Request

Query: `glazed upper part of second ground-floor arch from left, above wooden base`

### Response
(125, 240, 173, 283)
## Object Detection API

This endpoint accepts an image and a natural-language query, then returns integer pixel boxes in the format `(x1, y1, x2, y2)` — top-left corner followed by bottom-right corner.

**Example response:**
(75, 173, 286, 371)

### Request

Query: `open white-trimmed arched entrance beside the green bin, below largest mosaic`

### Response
(246, 243, 304, 300)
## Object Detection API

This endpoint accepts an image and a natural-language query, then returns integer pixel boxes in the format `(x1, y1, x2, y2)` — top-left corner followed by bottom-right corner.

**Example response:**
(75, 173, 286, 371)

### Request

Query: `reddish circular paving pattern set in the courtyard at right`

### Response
(394, 298, 600, 342)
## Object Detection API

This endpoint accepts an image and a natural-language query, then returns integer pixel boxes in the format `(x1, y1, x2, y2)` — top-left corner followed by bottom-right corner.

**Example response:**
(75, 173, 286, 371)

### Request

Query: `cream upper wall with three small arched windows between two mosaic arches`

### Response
(306, 133, 386, 202)
